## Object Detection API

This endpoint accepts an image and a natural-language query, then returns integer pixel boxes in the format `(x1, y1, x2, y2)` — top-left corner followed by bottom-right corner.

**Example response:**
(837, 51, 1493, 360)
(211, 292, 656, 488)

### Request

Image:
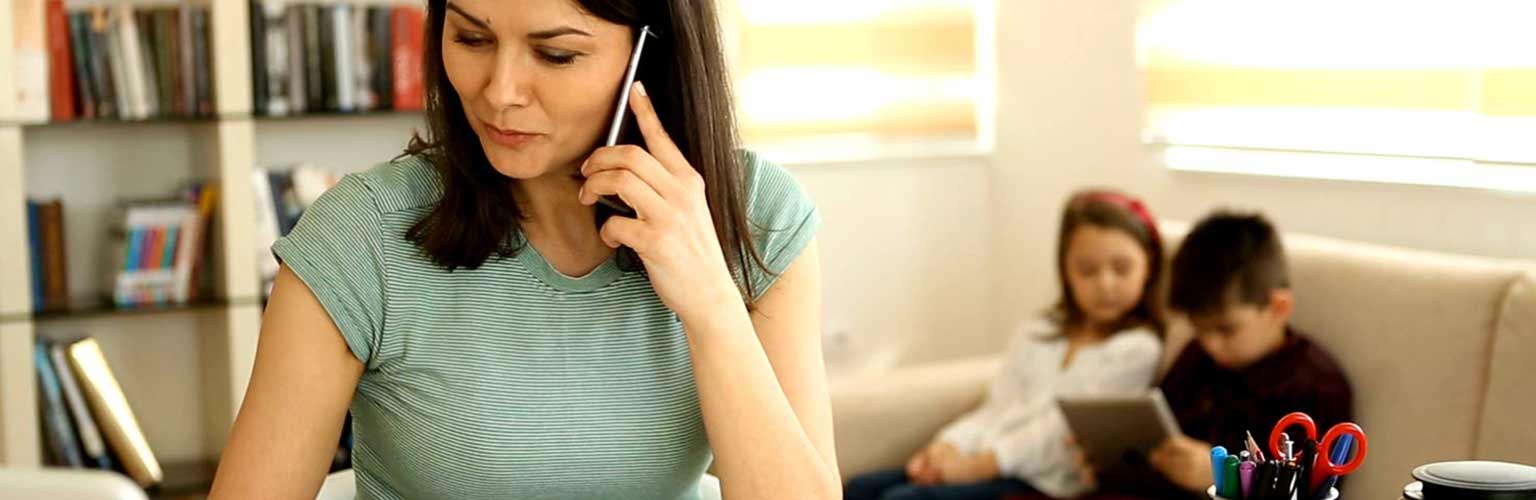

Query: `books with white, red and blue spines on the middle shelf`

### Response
(112, 183, 218, 308)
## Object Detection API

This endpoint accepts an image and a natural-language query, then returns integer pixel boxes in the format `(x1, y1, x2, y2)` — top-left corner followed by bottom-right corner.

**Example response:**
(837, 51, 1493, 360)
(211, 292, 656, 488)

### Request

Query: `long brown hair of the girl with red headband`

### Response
(1052, 190, 1166, 337)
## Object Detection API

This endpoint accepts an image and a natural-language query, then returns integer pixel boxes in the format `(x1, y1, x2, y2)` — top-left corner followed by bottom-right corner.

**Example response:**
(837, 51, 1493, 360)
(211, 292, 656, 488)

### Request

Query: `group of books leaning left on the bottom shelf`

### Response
(34, 337, 164, 488)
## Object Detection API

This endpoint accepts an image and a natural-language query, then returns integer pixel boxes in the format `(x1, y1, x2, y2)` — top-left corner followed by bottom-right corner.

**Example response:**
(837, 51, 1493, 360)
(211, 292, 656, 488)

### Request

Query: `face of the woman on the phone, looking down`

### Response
(442, 0, 633, 179)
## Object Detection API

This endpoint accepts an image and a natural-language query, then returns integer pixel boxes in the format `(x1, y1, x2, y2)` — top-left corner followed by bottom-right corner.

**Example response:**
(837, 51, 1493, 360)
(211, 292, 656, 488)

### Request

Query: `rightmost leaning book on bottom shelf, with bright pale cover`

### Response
(68, 337, 164, 488)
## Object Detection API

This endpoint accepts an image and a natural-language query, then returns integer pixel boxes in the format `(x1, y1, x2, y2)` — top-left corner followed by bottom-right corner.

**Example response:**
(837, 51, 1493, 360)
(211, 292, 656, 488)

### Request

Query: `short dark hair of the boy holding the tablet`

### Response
(1167, 210, 1290, 314)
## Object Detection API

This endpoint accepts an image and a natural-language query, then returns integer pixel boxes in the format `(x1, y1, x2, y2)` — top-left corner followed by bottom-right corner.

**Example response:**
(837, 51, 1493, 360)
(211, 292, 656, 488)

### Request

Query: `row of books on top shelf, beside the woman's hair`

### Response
(250, 0, 424, 115)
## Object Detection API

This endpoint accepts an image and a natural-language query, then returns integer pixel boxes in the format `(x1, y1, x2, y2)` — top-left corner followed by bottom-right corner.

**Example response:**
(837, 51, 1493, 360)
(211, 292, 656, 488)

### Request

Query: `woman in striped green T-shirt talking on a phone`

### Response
(212, 0, 840, 498)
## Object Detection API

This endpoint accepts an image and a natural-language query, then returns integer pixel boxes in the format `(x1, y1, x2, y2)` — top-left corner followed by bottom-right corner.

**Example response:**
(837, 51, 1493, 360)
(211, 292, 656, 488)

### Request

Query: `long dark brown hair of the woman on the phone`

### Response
(406, 0, 768, 305)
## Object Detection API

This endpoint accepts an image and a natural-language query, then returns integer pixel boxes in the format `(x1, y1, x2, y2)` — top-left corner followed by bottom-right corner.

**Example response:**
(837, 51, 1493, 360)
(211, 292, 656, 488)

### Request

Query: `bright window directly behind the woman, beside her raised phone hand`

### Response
(723, 0, 992, 156)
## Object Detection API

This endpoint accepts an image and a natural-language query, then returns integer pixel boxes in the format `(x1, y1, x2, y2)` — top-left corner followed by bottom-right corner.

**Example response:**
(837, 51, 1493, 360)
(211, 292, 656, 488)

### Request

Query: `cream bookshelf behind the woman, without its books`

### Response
(0, 0, 421, 468)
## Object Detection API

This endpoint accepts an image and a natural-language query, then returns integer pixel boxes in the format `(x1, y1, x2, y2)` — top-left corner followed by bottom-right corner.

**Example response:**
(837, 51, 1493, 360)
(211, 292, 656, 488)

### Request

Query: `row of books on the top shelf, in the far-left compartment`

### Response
(17, 0, 214, 121)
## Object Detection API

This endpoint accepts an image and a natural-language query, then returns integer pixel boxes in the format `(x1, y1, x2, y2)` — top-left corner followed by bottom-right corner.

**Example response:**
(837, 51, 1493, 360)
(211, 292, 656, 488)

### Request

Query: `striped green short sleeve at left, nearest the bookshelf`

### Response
(272, 175, 384, 365)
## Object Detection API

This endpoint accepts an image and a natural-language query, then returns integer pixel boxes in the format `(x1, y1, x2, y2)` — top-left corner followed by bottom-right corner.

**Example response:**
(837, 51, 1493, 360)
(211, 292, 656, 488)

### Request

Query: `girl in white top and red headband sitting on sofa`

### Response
(845, 190, 1163, 500)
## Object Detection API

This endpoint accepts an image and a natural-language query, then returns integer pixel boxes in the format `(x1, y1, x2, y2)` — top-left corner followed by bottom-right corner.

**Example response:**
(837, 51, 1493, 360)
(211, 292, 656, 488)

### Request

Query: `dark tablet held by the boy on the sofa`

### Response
(1057, 388, 1180, 491)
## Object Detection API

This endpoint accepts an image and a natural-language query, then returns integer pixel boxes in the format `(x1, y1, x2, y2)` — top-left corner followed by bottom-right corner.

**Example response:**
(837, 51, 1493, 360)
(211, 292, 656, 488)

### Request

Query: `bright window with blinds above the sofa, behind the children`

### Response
(1137, 0, 1536, 190)
